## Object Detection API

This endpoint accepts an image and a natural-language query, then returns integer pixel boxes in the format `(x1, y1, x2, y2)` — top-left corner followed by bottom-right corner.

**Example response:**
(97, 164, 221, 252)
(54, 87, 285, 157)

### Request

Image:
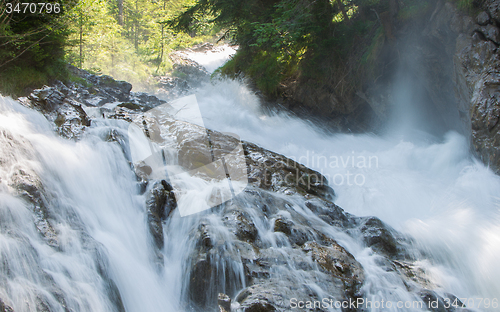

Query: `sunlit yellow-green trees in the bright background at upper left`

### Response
(63, 0, 214, 91)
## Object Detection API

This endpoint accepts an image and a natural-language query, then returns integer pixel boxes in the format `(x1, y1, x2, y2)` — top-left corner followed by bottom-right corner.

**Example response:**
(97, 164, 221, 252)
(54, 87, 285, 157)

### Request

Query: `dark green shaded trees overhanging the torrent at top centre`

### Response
(174, 0, 444, 98)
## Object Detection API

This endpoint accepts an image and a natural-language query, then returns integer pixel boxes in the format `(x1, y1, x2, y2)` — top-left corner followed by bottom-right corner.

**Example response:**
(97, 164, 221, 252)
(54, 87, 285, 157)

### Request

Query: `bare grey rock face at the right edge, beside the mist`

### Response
(454, 0, 500, 173)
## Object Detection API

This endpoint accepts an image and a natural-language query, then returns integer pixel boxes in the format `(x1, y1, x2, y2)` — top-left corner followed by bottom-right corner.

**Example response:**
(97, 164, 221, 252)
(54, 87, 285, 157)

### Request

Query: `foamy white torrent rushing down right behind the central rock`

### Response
(179, 46, 500, 311)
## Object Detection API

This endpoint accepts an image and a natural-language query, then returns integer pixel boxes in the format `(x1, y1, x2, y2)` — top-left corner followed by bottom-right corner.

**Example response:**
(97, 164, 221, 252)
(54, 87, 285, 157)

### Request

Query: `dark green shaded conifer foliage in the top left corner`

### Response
(0, 0, 74, 96)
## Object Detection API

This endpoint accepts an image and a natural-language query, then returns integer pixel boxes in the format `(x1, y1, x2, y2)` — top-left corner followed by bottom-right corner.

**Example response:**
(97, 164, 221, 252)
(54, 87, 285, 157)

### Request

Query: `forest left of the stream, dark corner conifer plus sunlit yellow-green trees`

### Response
(0, 0, 216, 95)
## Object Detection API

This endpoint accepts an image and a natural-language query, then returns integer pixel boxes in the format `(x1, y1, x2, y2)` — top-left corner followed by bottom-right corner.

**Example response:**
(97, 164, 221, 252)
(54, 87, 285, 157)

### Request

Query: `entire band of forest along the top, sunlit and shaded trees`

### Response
(0, 0, 478, 97)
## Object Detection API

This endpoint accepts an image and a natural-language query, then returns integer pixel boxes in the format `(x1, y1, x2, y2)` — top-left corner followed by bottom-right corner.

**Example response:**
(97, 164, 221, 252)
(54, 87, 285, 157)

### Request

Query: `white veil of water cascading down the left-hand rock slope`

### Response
(0, 99, 177, 311)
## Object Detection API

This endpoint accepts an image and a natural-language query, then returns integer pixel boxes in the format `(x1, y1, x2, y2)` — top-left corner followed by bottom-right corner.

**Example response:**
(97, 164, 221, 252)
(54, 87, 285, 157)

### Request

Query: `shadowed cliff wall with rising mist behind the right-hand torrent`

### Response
(282, 0, 500, 172)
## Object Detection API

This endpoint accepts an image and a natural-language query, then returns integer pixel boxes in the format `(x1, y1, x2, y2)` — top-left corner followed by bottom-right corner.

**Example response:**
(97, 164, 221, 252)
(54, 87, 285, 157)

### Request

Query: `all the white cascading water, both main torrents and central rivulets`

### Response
(0, 44, 500, 312)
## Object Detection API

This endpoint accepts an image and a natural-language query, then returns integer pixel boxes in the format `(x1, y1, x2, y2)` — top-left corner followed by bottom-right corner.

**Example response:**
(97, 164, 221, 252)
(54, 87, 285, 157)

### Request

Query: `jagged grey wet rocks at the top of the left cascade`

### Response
(19, 66, 165, 140)
